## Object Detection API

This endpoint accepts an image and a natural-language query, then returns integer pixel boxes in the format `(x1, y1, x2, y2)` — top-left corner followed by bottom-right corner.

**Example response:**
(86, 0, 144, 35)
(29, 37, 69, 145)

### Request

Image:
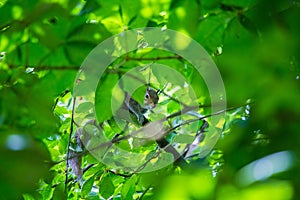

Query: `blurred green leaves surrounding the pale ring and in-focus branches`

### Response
(0, 0, 300, 200)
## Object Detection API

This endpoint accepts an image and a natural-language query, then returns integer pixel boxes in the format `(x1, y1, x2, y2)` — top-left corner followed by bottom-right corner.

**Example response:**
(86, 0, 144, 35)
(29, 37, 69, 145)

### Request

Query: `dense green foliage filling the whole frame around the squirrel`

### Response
(0, 0, 300, 200)
